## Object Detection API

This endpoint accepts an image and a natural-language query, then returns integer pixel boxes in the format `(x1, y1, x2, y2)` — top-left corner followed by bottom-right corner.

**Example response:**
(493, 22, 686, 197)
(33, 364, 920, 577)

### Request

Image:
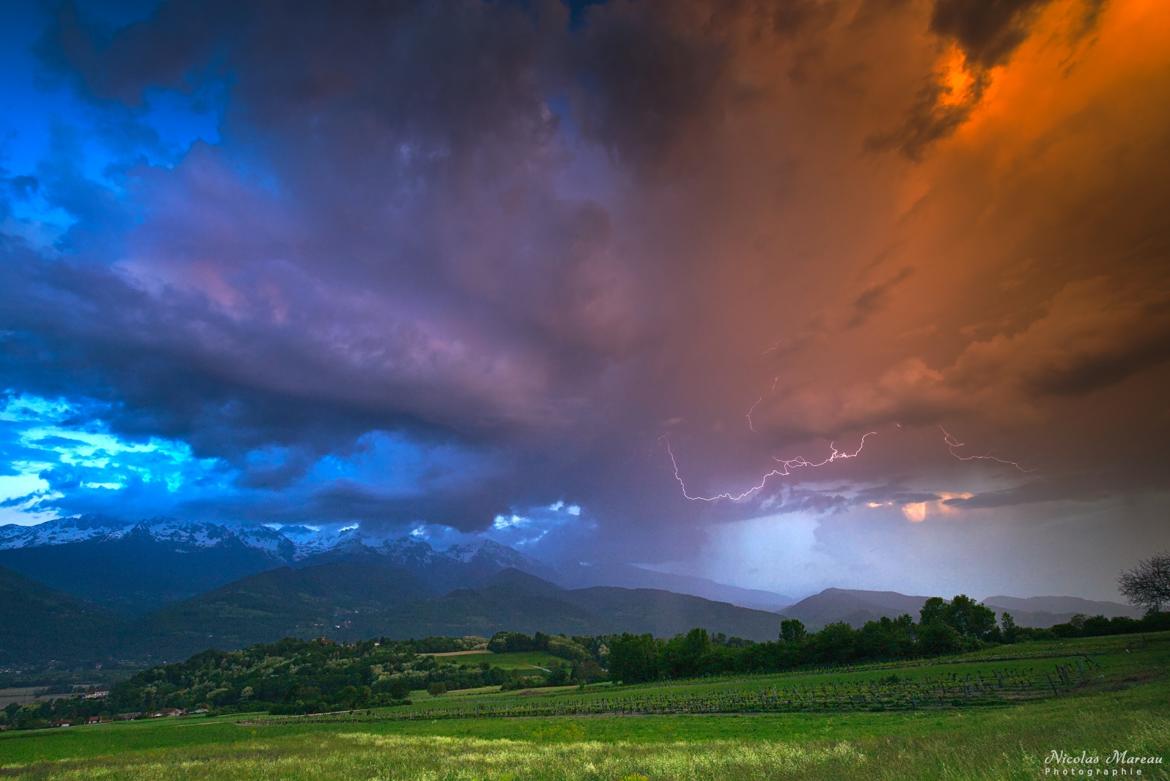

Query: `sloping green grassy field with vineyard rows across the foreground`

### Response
(0, 633, 1170, 781)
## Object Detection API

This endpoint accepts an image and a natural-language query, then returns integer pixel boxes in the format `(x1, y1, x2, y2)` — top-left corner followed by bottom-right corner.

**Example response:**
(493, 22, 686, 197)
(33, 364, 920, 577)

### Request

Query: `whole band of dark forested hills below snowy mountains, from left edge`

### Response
(0, 558, 780, 666)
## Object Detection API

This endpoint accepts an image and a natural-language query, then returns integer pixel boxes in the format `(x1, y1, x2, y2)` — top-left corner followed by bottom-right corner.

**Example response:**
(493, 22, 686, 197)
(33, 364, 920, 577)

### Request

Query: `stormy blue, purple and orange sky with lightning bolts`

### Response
(0, 0, 1170, 599)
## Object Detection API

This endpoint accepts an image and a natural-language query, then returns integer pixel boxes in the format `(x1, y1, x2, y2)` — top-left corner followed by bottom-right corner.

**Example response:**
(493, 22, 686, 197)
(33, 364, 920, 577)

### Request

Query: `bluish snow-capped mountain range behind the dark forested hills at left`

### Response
(0, 517, 549, 613)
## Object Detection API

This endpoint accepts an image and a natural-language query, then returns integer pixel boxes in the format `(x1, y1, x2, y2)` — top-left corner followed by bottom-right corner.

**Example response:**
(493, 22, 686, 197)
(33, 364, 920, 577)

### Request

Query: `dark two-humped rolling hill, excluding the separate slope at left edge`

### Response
(133, 560, 779, 659)
